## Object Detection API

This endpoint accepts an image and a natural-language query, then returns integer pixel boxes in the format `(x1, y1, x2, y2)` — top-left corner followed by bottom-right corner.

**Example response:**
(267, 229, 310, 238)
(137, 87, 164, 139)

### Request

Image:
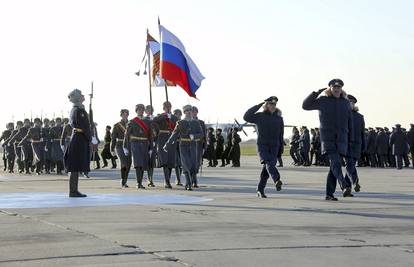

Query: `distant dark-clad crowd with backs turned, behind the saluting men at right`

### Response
(290, 124, 414, 169)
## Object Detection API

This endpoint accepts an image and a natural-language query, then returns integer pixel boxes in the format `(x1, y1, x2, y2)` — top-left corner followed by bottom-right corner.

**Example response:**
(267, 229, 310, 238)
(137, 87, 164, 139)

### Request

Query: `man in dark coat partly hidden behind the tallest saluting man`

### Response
(345, 95, 365, 192)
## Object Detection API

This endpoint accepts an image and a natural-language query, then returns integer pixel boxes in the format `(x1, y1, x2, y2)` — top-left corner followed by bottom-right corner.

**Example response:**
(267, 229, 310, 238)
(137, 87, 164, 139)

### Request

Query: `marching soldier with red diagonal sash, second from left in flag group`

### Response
(123, 104, 153, 189)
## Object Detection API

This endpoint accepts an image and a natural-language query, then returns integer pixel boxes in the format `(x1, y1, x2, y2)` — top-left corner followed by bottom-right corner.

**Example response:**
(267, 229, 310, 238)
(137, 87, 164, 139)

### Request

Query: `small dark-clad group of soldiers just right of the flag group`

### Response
(204, 127, 241, 168)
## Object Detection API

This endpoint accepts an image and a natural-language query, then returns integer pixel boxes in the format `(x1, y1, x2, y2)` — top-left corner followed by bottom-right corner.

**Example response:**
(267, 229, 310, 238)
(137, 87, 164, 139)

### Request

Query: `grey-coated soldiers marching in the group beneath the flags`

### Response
(109, 101, 207, 190)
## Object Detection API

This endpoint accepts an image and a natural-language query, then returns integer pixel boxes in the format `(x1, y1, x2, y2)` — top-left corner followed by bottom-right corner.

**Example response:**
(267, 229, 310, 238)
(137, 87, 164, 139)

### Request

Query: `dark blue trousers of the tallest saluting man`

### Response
(326, 153, 351, 196)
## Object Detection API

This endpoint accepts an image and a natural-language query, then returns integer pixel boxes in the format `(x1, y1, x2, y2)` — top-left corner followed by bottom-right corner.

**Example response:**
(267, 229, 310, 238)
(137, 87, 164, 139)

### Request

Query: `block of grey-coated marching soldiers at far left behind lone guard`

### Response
(0, 118, 72, 175)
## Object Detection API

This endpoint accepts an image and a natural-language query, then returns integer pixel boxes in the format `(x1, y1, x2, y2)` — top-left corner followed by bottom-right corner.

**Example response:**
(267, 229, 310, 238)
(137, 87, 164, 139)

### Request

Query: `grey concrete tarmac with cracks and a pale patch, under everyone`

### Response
(0, 157, 414, 267)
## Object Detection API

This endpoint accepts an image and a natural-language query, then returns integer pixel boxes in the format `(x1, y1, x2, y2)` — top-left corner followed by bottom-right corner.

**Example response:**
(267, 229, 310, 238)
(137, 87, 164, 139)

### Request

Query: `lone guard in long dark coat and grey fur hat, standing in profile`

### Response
(64, 89, 92, 197)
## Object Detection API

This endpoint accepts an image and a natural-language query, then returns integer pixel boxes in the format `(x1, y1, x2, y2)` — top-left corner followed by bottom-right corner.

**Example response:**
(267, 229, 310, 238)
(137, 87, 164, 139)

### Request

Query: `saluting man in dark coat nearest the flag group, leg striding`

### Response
(243, 96, 284, 198)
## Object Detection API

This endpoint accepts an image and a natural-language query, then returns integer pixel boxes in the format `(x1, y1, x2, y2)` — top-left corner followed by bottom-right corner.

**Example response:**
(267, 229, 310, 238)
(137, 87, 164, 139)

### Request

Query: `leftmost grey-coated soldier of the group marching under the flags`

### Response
(111, 109, 132, 188)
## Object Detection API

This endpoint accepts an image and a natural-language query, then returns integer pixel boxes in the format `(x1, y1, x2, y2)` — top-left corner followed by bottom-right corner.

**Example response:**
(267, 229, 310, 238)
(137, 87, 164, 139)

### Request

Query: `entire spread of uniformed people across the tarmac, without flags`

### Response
(0, 79, 414, 201)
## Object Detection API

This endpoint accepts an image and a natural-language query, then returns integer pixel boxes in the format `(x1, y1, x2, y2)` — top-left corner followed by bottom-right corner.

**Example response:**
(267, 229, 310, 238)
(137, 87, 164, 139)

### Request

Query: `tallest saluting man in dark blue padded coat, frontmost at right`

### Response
(302, 79, 354, 201)
